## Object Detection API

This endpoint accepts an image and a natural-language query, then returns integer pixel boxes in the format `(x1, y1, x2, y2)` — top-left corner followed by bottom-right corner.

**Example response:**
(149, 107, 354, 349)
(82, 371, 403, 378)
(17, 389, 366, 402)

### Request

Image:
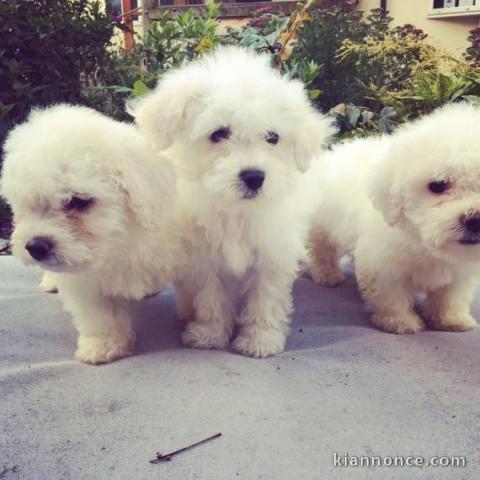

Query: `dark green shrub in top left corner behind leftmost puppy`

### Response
(0, 0, 120, 232)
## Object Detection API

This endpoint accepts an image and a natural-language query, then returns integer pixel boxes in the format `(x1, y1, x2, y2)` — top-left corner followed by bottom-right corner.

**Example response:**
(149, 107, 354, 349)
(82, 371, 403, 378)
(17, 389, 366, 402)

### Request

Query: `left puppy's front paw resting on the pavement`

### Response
(75, 335, 135, 365)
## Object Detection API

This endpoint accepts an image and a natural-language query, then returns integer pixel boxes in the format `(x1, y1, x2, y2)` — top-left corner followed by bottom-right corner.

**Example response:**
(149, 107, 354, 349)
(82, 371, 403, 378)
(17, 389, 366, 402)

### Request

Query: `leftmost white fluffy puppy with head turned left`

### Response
(1, 105, 181, 364)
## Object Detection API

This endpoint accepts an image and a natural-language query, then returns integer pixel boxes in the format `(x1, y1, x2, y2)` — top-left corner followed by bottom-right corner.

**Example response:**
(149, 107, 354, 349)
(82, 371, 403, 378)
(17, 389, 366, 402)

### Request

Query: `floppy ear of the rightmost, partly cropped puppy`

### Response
(369, 146, 403, 227)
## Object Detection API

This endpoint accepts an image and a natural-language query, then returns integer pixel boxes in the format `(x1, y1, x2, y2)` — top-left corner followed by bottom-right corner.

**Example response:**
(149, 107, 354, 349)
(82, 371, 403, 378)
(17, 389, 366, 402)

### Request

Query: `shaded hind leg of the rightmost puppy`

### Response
(309, 226, 345, 287)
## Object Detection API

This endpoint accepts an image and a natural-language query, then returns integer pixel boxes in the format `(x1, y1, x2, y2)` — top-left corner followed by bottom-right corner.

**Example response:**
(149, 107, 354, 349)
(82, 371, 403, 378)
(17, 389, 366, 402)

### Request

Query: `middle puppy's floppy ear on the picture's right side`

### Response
(294, 107, 336, 172)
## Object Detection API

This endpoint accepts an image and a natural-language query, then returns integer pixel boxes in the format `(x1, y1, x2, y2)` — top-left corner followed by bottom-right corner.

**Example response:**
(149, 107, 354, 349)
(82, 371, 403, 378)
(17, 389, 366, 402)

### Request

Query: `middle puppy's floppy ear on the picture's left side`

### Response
(127, 66, 202, 151)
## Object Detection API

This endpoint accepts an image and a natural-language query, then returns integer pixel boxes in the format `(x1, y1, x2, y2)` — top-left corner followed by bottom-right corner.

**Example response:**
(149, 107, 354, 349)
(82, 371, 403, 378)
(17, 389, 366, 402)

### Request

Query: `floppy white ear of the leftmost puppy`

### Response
(115, 145, 176, 229)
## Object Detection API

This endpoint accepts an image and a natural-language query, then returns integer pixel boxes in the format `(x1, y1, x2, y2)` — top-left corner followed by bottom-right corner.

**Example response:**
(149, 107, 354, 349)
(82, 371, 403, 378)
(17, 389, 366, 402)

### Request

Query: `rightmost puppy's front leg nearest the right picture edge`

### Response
(423, 280, 477, 332)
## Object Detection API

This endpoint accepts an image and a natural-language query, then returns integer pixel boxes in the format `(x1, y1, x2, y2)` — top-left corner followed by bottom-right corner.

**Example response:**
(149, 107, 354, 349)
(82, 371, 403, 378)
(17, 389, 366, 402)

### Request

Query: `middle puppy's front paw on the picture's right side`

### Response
(232, 327, 286, 358)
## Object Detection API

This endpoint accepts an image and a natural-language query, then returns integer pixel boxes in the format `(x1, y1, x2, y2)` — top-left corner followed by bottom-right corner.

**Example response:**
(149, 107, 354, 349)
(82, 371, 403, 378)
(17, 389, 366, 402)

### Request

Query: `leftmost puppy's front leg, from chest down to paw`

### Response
(59, 274, 135, 365)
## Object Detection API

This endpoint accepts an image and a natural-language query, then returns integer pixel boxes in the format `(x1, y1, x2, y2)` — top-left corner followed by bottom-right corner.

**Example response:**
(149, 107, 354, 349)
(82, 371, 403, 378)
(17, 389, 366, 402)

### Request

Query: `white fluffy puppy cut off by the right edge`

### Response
(311, 104, 480, 334)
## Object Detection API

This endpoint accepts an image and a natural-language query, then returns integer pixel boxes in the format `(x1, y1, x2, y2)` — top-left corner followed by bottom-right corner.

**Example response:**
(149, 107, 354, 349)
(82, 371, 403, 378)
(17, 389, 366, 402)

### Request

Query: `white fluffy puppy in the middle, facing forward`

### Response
(131, 48, 332, 357)
